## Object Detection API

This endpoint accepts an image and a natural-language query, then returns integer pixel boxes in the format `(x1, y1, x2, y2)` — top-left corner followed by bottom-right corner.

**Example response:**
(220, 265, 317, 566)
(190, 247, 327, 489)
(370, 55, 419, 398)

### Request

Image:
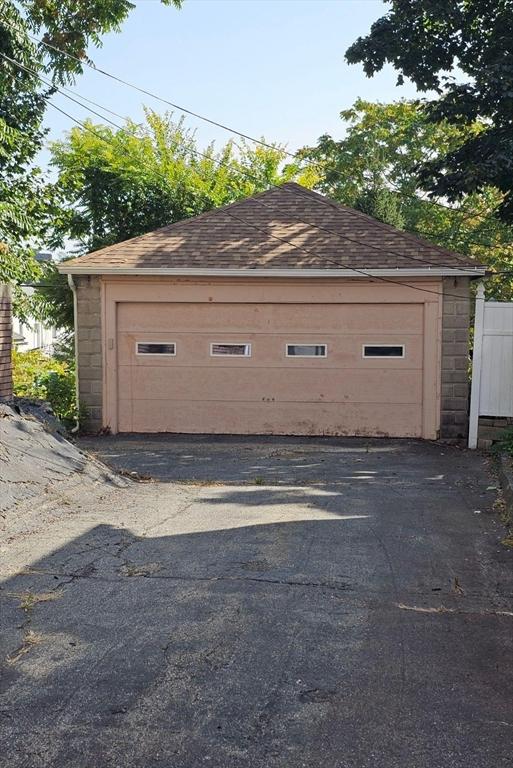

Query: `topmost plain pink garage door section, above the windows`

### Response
(118, 302, 423, 333)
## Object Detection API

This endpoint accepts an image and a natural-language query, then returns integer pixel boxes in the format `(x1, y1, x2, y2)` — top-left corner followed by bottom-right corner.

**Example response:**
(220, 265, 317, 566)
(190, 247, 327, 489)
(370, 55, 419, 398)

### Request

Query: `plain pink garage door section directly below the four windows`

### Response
(121, 367, 422, 404)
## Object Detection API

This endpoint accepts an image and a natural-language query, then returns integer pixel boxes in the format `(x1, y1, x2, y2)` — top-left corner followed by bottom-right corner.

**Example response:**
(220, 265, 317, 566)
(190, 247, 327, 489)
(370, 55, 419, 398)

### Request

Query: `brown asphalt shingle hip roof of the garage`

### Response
(62, 183, 481, 272)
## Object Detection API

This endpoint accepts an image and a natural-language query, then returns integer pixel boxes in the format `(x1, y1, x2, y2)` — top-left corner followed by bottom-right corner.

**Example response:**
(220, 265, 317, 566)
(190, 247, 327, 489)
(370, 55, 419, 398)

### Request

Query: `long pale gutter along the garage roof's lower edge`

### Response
(58, 262, 486, 278)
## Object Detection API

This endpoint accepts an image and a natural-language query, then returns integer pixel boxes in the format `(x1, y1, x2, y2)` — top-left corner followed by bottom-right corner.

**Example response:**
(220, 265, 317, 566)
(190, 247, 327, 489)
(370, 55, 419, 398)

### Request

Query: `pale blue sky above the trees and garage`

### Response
(45, 0, 415, 160)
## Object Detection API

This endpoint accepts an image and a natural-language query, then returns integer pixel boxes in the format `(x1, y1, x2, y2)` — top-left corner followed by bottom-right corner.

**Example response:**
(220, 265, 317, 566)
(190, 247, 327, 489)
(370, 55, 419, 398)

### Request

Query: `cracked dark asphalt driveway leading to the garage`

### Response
(0, 436, 513, 768)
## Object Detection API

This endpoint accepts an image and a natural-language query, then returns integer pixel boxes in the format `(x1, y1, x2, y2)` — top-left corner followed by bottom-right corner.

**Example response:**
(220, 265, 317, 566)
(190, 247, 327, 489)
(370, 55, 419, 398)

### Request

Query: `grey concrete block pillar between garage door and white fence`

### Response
(440, 277, 470, 440)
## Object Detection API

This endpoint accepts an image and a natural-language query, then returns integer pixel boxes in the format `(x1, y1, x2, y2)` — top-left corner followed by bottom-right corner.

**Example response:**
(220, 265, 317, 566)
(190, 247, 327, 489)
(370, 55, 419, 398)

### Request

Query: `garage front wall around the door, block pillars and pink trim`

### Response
(75, 276, 469, 437)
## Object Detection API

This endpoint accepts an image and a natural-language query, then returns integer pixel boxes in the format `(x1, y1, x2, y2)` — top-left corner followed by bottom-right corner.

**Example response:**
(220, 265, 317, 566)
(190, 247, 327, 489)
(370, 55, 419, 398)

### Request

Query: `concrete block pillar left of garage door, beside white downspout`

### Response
(75, 276, 103, 432)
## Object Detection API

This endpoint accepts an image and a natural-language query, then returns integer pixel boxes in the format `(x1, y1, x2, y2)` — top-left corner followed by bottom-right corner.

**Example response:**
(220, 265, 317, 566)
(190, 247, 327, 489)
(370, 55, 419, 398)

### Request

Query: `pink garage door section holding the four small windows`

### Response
(118, 331, 423, 370)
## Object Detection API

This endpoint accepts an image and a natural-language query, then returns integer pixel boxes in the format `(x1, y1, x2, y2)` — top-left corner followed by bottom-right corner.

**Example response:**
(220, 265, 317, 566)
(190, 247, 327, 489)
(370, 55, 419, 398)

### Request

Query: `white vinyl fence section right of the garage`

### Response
(468, 284, 513, 448)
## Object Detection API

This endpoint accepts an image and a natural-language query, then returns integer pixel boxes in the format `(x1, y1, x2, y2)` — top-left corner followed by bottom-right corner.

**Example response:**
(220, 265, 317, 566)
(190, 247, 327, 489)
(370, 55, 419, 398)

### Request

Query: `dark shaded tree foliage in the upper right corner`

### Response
(346, 0, 513, 223)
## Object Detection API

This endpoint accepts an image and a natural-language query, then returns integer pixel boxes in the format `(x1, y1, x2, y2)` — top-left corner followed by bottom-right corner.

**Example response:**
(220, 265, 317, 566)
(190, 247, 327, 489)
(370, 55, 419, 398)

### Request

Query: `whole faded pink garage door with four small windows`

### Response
(117, 302, 424, 437)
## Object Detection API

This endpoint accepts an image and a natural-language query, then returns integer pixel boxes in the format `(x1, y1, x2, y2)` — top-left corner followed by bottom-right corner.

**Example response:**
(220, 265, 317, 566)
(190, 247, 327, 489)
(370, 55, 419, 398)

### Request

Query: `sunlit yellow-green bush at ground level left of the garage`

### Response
(13, 349, 77, 426)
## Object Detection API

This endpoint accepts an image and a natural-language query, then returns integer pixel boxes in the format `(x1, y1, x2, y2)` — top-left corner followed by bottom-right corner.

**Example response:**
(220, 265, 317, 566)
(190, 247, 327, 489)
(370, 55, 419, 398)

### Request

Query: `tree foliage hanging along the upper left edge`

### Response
(0, 0, 181, 308)
